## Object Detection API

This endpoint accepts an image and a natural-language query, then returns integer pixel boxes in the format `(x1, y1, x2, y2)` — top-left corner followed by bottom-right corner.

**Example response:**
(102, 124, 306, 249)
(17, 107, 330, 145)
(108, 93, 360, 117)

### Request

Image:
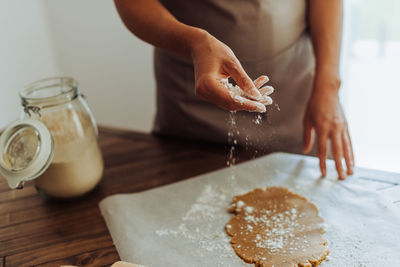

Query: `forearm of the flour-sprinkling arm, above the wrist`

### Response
(114, 0, 206, 57)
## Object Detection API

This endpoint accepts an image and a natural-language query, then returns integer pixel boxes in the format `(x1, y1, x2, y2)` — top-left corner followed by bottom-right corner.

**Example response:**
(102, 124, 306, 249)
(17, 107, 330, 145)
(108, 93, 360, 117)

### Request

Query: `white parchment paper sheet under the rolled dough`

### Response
(100, 153, 400, 267)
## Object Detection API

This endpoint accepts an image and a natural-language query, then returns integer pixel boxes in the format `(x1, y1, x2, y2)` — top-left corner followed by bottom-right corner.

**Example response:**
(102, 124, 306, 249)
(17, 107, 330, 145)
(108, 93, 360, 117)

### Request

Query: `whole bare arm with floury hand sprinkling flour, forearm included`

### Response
(115, 0, 271, 112)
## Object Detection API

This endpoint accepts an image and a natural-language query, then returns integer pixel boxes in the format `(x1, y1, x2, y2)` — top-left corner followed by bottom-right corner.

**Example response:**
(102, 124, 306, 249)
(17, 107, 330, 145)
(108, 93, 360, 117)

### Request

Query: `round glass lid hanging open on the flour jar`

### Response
(0, 119, 54, 189)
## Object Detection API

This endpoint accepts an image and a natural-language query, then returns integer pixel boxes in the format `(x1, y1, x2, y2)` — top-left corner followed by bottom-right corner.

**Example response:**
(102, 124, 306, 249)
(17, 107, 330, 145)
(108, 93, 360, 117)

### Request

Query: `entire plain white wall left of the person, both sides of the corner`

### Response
(0, 0, 155, 131)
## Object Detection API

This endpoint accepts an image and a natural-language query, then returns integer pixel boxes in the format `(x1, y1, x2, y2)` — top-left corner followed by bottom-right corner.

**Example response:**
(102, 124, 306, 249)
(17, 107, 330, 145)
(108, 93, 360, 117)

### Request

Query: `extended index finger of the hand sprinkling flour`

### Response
(228, 61, 265, 100)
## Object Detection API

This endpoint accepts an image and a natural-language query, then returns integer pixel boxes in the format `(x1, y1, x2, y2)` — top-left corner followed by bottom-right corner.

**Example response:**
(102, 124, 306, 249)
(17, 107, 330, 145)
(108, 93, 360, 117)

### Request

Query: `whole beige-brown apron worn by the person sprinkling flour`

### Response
(154, 0, 315, 153)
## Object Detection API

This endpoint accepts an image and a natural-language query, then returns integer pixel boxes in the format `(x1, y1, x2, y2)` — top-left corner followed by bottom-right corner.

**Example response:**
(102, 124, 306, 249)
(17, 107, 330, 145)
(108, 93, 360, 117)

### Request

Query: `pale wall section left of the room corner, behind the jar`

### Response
(0, 0, 59, 129)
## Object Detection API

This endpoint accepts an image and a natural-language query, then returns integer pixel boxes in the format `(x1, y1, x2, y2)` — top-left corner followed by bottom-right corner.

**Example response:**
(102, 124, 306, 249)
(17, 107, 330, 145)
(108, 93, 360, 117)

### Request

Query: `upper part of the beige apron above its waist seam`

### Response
(161, 0, 307, 60)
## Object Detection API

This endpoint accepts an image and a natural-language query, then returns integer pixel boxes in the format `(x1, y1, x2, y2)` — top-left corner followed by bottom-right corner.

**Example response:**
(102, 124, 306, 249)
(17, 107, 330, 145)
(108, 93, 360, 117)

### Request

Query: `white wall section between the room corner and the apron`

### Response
(44, 0, 155, 131)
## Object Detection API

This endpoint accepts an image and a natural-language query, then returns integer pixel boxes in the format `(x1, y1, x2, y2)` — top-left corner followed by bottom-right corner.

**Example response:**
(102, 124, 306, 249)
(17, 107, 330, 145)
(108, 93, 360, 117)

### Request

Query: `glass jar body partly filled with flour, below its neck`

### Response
(35, 110, 103, 198)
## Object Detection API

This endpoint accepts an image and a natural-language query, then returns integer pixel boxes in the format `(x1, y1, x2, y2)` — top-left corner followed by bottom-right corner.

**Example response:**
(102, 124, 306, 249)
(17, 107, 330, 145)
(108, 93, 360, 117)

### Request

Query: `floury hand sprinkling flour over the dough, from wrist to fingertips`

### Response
(191, 31, 268, 112)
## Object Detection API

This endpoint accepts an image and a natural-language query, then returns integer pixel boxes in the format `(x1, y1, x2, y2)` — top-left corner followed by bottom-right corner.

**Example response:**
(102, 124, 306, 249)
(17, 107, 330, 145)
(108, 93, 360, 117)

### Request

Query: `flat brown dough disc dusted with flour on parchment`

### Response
(225, 187, 329, 267)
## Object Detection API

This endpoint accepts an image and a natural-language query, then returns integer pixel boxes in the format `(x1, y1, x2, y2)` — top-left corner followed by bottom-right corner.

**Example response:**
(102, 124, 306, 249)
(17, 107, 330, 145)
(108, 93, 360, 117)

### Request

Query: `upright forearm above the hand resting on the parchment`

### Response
(309, 0, 343, 90)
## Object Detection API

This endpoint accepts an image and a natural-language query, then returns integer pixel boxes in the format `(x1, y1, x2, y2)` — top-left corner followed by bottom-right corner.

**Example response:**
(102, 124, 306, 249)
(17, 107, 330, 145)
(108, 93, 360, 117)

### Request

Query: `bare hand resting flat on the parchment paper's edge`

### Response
(304, 75, 354, 179)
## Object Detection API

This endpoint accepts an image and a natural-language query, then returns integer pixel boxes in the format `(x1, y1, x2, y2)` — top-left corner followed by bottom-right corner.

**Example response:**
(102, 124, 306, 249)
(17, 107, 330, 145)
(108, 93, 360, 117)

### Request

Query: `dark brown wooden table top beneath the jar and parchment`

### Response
(0, 127, 258, 267)
